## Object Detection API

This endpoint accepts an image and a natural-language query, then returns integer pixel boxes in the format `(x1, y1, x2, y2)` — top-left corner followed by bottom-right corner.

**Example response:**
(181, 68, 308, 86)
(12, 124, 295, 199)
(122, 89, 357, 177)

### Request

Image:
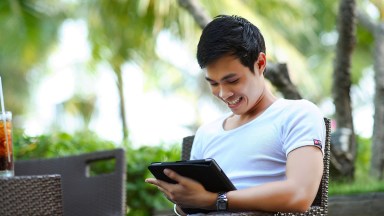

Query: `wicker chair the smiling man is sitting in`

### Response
(181, 118, 331, 216)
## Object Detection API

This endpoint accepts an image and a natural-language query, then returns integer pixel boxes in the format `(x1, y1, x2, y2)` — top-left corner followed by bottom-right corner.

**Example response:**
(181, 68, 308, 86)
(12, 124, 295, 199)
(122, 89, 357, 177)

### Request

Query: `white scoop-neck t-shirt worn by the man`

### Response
(191, 99, 325, 189)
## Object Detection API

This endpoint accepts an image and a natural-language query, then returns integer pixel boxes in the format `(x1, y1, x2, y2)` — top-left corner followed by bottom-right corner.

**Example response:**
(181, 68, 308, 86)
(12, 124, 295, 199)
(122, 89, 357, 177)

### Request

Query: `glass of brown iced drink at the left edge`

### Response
(0, 111, 14, 177)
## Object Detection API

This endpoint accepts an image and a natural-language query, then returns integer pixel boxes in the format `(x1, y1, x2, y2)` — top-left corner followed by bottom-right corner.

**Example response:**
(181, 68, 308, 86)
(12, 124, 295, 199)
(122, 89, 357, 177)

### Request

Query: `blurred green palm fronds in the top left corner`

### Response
(0, 0, 67, 115)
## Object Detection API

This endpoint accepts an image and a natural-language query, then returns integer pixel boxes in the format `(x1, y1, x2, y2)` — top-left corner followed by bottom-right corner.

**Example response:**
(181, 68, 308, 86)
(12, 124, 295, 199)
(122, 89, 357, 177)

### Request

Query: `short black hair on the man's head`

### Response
(197, 15, 265, 72)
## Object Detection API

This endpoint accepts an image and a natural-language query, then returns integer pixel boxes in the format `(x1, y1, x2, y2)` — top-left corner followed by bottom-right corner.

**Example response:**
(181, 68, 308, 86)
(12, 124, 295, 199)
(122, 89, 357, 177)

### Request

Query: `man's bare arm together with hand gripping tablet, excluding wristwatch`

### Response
(146, 146, 323, 212)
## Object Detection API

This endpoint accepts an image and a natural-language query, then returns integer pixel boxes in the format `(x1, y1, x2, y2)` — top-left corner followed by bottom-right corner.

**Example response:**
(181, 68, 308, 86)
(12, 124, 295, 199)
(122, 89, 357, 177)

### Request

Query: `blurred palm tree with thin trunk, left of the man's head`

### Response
(84, 0, 202, 144)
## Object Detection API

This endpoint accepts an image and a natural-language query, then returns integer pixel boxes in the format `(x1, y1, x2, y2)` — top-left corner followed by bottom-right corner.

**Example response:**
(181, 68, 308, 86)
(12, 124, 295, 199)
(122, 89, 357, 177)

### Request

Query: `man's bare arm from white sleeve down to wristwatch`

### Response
(227, 146, 323, 212)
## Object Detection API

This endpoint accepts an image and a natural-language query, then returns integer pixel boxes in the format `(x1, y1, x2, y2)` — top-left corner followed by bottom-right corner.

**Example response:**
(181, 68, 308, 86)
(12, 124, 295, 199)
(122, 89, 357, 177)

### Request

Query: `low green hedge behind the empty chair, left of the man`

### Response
(13, 130, 180, 216)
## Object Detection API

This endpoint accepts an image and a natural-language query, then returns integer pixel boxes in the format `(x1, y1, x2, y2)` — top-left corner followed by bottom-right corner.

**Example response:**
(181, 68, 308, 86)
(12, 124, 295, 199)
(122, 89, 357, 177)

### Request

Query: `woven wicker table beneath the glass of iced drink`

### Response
(0, 175, 63, 216)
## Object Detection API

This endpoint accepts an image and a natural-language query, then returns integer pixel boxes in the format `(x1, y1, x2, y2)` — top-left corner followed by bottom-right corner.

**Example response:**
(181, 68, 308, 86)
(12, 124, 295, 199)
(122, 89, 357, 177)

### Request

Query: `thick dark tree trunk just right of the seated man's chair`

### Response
(331, 0, 356, 180)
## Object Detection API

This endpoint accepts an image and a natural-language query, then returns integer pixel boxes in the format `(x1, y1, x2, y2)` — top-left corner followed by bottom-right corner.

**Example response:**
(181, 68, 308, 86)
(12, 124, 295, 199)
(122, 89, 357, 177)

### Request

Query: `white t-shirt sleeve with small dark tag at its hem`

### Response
(282, 100, 325, 157)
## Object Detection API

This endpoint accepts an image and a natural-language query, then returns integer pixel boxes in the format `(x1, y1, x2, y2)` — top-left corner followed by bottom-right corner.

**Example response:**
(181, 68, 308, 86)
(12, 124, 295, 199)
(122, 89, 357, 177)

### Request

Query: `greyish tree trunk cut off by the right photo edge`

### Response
(371, 23, 384, 179)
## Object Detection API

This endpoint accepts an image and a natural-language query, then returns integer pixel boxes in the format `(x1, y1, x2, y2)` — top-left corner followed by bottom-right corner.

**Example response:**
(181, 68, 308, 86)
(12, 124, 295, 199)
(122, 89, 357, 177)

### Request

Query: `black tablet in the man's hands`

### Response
(148, 158, 236, 214)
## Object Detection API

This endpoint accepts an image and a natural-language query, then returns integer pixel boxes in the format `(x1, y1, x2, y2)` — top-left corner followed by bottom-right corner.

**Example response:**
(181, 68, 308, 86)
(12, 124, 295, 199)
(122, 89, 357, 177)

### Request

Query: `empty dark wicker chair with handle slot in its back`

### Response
(15, 149, 126, 216)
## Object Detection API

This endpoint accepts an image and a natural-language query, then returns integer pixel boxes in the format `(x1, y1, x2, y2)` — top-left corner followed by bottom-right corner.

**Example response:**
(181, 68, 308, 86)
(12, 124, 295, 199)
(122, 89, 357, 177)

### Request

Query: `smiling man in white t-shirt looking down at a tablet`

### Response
(146, 15, 325, 214)
